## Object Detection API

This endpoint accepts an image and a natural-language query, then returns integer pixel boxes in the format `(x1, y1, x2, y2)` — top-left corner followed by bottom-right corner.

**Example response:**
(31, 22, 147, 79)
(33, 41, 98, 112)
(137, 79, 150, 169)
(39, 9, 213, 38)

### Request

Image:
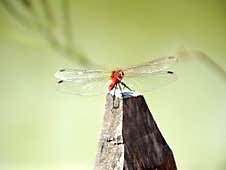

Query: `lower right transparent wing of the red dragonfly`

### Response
(123, 71, 177, 93)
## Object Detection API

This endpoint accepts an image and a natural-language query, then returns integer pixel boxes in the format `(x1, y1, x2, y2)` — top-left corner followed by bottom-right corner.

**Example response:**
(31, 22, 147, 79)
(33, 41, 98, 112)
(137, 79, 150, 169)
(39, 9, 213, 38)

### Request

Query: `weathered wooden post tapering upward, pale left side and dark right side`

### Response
(94, 92, 177, 170)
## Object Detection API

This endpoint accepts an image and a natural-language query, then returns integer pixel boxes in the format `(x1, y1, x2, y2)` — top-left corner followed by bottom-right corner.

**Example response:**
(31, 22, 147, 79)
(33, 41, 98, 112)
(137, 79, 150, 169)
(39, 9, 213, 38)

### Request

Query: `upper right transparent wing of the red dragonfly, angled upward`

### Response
(123, 56, 177, 77)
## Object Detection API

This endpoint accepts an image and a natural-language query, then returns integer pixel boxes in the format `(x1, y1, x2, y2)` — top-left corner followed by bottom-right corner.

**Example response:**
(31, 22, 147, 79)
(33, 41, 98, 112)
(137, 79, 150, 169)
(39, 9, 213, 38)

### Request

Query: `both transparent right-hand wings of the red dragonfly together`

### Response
(123, 56, 177, 92)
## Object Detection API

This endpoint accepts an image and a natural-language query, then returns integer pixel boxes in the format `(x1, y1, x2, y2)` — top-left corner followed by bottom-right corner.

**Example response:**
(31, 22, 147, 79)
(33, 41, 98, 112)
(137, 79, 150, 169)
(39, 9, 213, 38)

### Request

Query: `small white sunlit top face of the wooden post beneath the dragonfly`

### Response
(107, 89, 143, 99)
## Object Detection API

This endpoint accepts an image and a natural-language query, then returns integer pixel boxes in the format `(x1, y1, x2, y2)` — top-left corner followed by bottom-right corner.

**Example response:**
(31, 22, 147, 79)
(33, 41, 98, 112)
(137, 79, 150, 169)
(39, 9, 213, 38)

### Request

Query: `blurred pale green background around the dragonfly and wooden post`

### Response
(0, 0, 226, 170)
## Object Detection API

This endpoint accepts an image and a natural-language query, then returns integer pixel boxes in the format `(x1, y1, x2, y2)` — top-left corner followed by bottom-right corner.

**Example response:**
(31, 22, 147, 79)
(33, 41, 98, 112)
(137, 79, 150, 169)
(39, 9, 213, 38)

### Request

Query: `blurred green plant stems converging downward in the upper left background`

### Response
(0, 0, 92, 66)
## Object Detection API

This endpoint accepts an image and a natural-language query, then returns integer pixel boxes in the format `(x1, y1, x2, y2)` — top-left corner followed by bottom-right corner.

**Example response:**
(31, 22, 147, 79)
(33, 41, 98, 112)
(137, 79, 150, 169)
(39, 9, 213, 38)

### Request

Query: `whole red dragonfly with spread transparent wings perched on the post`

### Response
(55, 56, 177, 95)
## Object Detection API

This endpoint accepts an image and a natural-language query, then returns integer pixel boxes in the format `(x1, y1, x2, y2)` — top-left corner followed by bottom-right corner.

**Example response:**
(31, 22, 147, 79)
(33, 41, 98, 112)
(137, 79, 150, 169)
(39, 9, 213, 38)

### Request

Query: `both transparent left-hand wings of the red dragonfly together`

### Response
(55, 69, 109, 95)
